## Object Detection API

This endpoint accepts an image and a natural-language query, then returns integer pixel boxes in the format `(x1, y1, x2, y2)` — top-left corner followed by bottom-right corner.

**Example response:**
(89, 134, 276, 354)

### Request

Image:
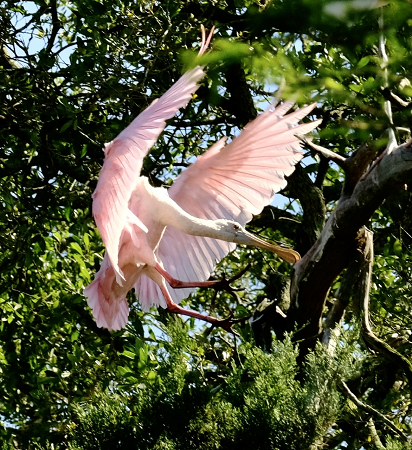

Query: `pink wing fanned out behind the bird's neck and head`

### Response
(136, 102, 320, 304)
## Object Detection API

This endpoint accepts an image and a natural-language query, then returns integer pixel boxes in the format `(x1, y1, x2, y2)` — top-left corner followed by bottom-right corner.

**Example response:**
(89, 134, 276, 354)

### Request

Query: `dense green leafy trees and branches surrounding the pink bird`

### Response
(0, 0, 412, 449)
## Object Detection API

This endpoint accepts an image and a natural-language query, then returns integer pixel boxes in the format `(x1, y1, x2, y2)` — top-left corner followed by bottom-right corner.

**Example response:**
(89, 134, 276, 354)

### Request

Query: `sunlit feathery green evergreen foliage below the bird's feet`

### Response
(60, 325, 353, 450)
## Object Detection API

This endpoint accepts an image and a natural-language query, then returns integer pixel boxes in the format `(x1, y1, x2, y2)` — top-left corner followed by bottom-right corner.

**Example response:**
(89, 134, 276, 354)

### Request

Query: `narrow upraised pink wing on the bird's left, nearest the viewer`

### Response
(93, 66, 204, 284)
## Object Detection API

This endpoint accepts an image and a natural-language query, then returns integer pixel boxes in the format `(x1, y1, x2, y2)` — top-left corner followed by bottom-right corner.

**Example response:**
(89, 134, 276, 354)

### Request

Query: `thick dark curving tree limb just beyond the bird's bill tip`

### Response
(286, 145, 412, 339)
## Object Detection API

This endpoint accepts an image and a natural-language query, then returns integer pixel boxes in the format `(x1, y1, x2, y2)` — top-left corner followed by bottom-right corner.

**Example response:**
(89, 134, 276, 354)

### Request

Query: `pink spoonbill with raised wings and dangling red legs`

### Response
(84, 28, 321, 331)
